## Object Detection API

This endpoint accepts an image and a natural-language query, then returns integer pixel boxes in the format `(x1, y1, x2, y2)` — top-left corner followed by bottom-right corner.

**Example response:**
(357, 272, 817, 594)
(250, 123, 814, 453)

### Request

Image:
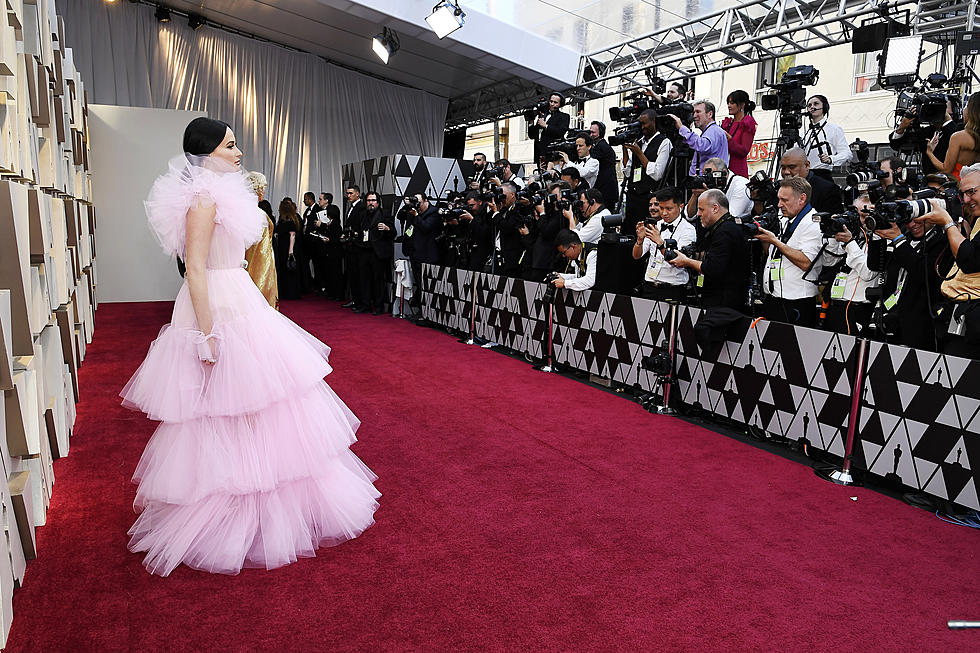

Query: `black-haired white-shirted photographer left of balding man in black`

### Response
(633, 189, 698, 301)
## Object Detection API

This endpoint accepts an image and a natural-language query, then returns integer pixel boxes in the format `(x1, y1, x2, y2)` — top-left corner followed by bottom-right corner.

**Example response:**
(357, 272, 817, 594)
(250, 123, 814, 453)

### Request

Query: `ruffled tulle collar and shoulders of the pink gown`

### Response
(143, 155, 265, 258)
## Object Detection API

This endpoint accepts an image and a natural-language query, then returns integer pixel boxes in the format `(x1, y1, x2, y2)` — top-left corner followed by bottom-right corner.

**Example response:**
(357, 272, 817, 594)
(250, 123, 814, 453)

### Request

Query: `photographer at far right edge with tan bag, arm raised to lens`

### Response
(917, 163, 980, 358)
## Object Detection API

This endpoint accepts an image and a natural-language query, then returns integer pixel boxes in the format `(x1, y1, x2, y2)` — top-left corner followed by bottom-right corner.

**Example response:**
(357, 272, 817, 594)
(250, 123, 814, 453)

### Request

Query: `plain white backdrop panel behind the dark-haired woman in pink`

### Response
(88, 104, 204, 302)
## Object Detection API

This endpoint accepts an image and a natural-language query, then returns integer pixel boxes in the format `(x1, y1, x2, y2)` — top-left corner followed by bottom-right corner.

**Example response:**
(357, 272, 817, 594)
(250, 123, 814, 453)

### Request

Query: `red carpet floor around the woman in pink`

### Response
(7, 300, 980, 652)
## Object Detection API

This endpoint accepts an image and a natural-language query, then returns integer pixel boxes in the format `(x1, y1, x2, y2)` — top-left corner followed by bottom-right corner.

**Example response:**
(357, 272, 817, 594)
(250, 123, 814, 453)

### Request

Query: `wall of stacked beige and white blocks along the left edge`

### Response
(0, 0, 97, 646)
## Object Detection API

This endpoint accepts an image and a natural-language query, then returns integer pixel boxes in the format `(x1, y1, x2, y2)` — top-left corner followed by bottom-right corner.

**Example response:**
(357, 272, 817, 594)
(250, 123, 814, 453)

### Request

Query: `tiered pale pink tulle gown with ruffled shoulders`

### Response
(121, 156, 381, 576)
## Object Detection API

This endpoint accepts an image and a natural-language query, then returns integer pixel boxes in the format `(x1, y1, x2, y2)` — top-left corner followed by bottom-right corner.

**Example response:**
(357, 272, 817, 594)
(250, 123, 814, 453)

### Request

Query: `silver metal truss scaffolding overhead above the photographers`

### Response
(447, 0, 978, 127)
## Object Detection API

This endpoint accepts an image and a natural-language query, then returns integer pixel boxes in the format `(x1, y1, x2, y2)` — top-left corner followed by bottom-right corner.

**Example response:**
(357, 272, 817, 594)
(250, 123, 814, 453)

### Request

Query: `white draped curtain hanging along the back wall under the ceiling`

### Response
(57, 0, 447, 204)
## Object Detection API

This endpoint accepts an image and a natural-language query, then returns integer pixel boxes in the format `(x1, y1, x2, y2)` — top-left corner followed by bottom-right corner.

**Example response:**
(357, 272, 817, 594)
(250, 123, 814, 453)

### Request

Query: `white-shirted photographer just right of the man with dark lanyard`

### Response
(823, 195, 881, 337)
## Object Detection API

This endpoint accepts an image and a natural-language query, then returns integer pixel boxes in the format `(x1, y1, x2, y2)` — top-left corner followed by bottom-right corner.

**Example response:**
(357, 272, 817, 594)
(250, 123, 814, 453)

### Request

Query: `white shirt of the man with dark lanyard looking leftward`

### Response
(762, 207, 823, 299)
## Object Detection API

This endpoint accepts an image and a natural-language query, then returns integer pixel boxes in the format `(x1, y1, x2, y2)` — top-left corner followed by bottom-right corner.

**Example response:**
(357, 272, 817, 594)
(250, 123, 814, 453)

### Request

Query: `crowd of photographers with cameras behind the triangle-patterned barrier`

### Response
(328, 66, 980, 357)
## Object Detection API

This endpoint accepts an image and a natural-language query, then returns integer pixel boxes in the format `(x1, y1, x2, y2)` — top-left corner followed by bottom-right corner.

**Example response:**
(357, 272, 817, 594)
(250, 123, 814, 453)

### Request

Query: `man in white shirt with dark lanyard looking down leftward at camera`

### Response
(756, 177, 823, 327)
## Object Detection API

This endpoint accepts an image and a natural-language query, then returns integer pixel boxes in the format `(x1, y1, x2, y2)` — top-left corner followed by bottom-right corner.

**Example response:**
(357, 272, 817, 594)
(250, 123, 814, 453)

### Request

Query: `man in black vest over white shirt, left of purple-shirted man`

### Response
(622, 109, 671, 233)
